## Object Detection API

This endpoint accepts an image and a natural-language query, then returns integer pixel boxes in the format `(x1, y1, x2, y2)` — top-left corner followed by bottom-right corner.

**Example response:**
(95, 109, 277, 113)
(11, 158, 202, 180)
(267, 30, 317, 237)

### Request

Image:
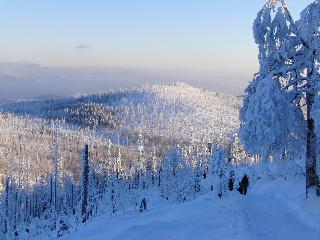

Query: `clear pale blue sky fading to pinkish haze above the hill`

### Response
(0, 0, 312, 96)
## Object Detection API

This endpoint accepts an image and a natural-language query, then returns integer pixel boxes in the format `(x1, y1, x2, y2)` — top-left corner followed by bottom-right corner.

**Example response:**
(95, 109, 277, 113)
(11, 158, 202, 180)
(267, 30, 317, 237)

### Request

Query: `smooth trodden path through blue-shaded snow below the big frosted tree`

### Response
(242, 194, 320, 240)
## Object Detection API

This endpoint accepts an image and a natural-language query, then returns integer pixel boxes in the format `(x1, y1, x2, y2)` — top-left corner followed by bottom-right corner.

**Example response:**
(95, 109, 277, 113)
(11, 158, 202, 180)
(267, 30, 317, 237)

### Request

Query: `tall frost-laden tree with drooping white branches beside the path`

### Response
(240, 0, 320, 196)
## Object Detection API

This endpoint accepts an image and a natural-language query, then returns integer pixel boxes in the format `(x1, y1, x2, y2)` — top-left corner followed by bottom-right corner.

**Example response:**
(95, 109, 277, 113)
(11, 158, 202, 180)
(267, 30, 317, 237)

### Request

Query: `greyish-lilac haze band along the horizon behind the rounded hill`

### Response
(0, 62, 250, 100)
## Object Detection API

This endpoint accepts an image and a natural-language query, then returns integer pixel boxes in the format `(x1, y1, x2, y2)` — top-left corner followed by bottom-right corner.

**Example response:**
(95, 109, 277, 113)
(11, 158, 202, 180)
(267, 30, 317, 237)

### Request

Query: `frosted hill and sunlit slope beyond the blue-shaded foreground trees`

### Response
(0, 82, 242, 182)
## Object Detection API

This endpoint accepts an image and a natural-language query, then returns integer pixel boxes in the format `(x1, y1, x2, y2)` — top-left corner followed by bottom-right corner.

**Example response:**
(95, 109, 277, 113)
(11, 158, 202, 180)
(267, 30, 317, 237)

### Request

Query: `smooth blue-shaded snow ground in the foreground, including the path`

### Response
(60, 179, 320, 240)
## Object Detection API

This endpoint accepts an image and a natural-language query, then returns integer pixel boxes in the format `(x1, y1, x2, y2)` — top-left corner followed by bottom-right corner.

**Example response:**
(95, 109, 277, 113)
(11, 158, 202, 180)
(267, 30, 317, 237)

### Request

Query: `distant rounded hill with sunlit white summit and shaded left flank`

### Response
(1, 82, 242, 141)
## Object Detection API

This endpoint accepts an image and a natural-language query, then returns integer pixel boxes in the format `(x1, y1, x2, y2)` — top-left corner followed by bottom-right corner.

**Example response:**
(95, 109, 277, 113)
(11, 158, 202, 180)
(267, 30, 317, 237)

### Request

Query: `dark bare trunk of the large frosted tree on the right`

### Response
(306, 93, 318, 197)
